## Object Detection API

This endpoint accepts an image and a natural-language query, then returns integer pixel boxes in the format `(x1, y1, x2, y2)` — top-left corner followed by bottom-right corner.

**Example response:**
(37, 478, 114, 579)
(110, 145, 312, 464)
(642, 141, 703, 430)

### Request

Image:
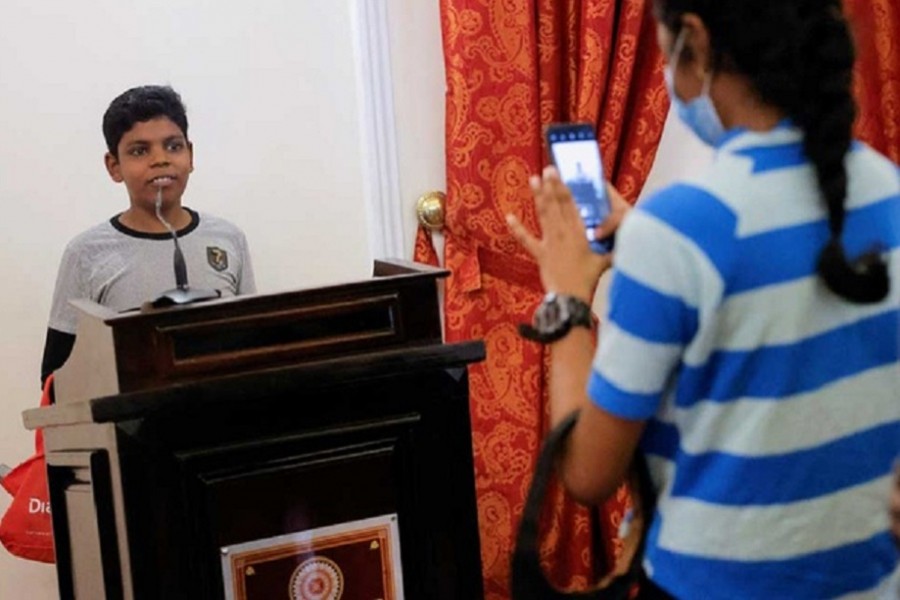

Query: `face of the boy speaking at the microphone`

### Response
(105, 117, 194, 208)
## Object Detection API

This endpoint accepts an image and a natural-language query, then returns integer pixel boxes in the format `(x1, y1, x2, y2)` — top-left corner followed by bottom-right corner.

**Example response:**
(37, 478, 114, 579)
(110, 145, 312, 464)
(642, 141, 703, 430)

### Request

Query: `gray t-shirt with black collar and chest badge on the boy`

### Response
(49, 209, 256, 334)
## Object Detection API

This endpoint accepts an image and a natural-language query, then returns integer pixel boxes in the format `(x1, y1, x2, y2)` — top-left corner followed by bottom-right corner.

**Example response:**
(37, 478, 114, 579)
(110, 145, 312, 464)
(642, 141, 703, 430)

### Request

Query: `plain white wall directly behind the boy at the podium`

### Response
(0, 0, 372, 600)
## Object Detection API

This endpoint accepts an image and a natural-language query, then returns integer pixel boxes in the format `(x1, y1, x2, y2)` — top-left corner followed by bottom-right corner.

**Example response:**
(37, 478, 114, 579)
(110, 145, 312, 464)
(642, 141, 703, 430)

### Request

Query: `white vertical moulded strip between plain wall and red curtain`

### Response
(351, 0, 445, 259)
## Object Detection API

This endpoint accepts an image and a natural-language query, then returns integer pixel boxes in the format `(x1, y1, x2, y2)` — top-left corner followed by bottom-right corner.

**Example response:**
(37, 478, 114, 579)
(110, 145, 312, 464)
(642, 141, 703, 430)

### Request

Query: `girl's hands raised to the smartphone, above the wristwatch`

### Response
(506, 167, 629, 303)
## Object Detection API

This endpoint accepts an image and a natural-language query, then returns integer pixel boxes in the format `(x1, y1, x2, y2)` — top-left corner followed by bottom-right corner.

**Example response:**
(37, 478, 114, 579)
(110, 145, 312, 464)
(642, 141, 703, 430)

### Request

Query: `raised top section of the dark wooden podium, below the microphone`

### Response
(49, 261, 458, 404)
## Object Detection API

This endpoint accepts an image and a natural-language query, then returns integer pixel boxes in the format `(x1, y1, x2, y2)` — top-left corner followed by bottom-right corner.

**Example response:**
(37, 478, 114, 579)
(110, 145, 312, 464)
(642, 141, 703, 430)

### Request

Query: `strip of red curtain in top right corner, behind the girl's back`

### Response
(844, 0, 900, 164)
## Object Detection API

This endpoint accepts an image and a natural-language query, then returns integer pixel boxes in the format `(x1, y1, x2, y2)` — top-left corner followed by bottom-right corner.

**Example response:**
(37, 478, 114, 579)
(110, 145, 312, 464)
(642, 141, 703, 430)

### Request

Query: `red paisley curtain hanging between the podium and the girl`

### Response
(416, 0, 668, 600)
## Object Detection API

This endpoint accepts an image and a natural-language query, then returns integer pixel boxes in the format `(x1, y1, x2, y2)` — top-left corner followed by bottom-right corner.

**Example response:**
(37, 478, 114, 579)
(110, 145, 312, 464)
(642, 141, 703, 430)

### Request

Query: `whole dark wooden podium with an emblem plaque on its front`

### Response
(25, 262, 484, 600)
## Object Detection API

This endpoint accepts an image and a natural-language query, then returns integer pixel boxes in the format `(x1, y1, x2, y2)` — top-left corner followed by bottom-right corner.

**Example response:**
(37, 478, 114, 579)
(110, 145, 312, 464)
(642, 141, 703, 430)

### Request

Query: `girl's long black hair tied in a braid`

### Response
(654, 0, 890, 303)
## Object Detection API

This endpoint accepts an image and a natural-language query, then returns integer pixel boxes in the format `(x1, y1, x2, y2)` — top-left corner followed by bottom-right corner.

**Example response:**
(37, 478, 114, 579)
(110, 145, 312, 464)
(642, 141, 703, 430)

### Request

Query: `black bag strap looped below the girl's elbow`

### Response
(511, 411, 656, 600)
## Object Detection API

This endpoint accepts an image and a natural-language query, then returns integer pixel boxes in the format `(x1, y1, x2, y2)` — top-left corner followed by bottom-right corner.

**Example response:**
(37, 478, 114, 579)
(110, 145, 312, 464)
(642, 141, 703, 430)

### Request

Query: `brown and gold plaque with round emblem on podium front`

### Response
(221, 514, 403, 600)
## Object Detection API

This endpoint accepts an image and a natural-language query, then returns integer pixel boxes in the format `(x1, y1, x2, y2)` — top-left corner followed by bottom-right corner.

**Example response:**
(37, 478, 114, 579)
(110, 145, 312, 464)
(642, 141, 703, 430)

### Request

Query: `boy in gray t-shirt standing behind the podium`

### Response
(41, 86, 256, 384)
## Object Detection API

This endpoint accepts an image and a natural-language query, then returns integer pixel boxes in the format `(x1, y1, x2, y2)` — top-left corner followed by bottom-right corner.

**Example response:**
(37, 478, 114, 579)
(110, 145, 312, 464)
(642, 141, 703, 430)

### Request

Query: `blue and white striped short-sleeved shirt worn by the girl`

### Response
(589, 123, 900, 600)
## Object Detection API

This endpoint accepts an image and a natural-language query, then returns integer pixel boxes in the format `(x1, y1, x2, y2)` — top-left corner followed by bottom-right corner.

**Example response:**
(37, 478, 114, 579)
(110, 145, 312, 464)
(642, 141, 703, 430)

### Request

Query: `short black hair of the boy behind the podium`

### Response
(103, 85, 187, 158)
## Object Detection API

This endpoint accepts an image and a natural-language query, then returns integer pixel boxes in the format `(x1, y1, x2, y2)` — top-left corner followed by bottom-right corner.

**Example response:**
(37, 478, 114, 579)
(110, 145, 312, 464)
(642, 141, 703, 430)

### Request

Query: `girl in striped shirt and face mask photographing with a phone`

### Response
(510, 0, 900, 600)
